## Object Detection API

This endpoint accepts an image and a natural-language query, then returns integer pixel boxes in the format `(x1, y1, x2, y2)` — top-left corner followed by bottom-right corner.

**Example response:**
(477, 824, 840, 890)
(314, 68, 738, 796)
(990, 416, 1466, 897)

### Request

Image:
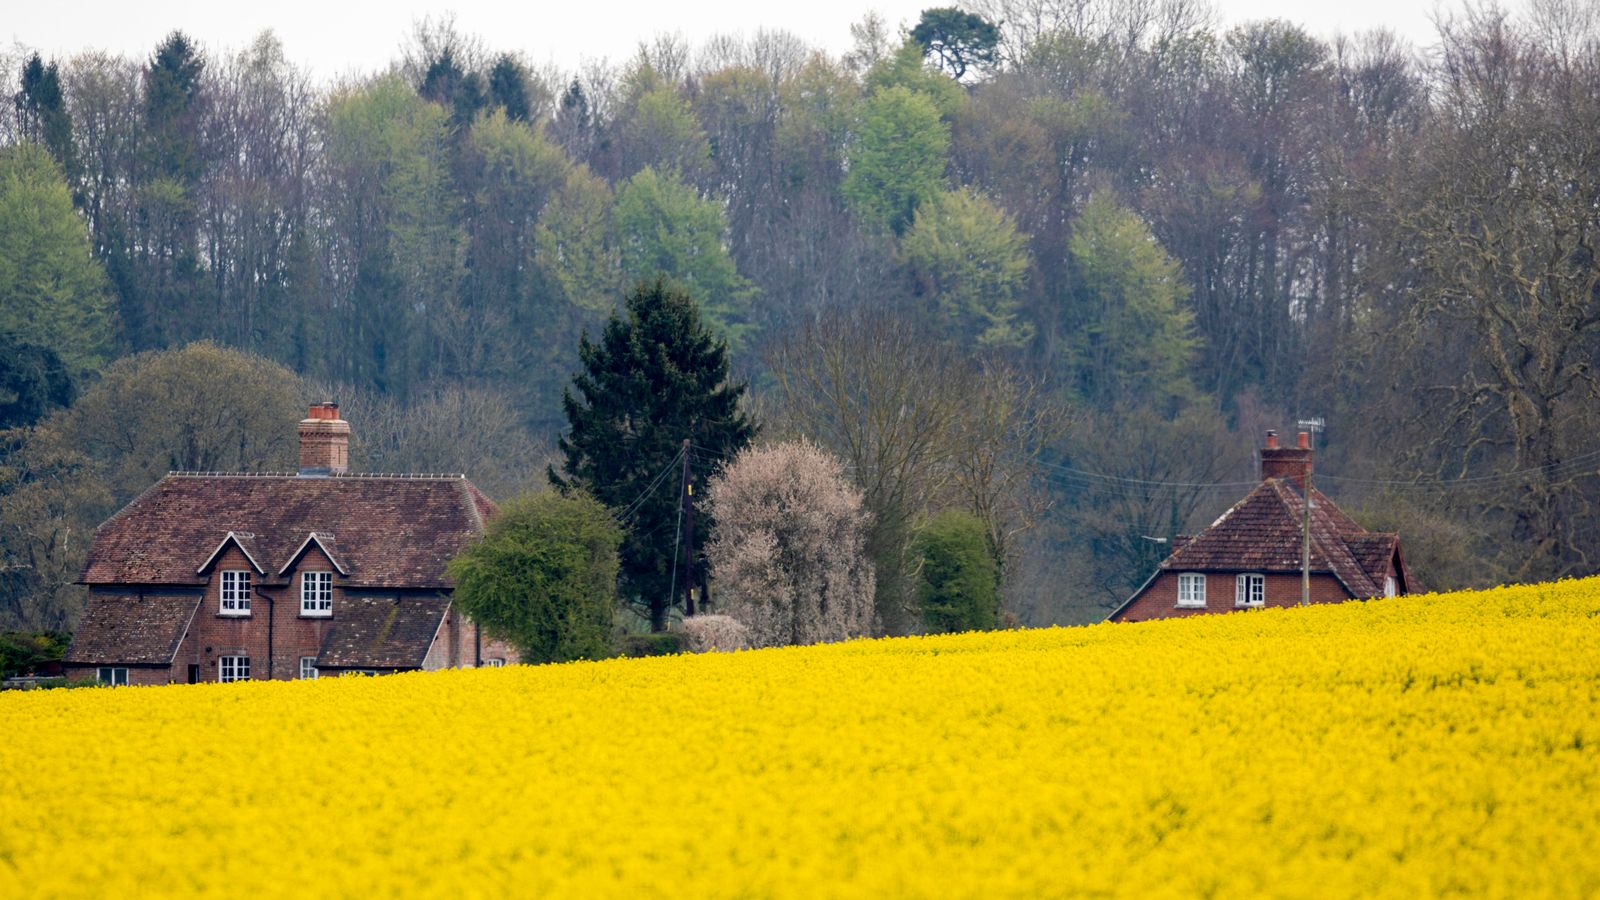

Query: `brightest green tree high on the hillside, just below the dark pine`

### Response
(840, 86, 950, 234)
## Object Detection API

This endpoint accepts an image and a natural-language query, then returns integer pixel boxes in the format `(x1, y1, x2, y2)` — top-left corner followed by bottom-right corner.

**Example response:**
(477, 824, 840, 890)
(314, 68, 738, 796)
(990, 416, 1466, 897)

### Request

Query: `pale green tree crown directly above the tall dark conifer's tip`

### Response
(613, 167, 755, 349)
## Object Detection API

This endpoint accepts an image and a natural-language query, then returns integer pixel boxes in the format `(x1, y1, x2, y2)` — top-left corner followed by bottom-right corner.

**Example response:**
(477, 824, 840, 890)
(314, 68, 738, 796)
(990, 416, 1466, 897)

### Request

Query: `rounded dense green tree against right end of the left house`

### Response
(450, 490, 622, 663)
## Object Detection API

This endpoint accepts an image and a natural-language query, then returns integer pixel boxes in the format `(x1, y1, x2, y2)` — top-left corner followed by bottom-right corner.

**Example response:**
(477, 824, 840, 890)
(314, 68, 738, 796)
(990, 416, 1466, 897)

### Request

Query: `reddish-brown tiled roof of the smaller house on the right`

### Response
(1162, 479, 1400, 597)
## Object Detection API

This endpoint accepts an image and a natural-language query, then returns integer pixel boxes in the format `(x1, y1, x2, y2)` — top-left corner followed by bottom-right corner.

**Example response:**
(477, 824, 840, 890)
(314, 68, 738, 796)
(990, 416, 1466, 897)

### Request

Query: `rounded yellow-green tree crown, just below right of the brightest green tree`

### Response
(901, 187, 1034, 348)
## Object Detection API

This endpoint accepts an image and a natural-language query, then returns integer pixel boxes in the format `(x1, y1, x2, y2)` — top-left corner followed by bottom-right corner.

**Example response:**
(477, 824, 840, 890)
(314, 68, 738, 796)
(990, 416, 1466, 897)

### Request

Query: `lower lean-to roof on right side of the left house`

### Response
(317, 596, 450, 669)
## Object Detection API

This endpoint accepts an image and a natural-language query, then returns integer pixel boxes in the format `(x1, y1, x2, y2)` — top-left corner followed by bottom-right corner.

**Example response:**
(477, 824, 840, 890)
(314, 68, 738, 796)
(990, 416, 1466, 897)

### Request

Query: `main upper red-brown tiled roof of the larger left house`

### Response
(82, 474, 494, 589)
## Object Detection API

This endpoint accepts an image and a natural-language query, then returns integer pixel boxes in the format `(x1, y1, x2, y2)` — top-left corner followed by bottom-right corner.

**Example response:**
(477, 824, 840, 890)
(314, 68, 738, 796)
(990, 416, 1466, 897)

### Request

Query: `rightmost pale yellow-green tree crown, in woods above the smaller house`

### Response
(1070, 194, 1200, 408)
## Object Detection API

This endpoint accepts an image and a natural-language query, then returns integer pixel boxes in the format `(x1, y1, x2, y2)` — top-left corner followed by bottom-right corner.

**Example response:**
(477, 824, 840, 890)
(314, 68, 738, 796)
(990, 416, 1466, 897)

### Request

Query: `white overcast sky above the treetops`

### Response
(0, 0, 1435, 80)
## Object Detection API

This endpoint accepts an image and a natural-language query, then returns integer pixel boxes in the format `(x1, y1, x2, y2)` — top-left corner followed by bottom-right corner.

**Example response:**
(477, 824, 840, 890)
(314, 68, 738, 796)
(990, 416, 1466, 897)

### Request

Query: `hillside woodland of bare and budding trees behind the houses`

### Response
(0, 0, 1600, 629)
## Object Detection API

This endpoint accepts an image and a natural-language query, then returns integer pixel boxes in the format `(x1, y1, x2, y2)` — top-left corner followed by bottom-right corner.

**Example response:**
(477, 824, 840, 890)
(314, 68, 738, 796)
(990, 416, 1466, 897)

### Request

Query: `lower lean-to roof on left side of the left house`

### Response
(67, 593, 200, 666)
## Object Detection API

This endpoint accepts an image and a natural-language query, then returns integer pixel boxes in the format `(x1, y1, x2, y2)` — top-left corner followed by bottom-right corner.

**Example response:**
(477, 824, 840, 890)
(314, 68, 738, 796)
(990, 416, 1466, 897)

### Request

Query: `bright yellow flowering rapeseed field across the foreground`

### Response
(0, 580, 1600, 900)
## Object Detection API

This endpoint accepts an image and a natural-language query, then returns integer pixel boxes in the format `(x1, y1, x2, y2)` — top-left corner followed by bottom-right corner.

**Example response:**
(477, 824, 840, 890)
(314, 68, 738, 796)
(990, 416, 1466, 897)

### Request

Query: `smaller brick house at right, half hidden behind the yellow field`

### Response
(1110, 431, 1421, 621)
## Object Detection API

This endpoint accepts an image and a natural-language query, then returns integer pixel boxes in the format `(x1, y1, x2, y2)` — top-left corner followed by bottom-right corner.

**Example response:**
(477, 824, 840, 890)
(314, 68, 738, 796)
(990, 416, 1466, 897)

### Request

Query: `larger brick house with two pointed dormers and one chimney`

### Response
(66, 404, 515, 684)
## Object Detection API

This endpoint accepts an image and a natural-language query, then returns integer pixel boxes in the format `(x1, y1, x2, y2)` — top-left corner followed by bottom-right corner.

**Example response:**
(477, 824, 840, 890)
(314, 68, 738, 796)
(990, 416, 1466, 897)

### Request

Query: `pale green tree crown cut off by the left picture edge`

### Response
(0, 143, 112, 375)
